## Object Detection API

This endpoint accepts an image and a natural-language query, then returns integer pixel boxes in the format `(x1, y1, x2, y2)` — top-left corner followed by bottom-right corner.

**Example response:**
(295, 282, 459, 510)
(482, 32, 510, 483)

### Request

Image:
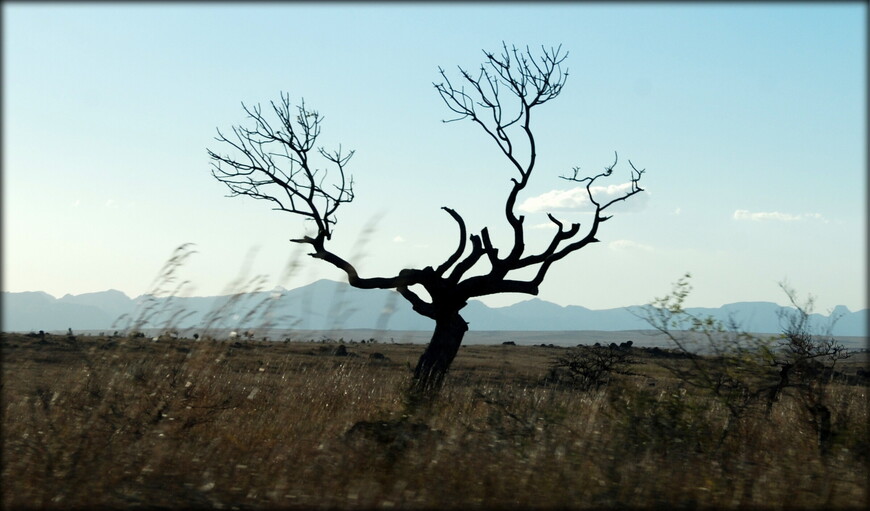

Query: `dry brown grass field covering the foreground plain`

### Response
(2, 334, 868, 509)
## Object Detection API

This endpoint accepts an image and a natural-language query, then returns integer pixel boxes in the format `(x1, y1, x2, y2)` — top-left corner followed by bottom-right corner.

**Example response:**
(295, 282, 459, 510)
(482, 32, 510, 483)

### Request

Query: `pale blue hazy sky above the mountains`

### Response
(3, 3, 867, 312)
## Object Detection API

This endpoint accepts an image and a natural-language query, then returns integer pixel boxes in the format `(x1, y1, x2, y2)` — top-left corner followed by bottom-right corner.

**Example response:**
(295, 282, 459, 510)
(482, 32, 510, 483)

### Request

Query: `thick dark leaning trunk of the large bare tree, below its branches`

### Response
(411, 313, 468, 399)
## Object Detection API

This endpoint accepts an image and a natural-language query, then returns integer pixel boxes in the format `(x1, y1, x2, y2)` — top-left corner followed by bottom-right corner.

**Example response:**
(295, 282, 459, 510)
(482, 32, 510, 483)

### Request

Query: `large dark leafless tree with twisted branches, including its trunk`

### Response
(208, 45, 644, 402)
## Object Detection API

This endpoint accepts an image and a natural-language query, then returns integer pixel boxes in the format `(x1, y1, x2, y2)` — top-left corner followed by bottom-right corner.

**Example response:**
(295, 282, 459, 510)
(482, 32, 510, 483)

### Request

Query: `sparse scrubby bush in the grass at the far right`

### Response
(638, 273, 850, 455)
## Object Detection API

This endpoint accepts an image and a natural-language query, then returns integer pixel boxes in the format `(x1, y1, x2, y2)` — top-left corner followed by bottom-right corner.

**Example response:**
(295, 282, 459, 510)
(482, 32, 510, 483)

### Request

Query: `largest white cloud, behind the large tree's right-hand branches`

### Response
(518, 183, 648, 213)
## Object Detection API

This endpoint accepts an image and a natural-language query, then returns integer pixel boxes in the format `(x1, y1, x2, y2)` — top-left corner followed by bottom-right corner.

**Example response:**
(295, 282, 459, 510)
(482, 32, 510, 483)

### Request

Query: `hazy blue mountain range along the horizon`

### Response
(2, 279, 868, 336)
